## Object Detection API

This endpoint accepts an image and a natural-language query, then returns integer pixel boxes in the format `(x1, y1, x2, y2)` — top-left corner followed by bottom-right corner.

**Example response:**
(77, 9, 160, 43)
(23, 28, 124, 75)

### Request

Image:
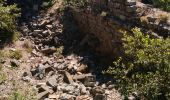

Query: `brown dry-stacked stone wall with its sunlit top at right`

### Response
(71, 0, 170, 56)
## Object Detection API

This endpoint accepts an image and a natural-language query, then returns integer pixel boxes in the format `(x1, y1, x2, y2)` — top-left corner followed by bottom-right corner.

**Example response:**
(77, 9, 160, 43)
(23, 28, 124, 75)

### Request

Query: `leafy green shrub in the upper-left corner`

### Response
(0, 0, 19, 31)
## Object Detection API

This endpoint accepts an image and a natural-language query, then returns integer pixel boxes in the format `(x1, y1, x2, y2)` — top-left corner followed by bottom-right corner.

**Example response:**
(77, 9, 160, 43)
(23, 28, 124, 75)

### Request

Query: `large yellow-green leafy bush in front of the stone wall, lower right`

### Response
(106, 28, 170, 100)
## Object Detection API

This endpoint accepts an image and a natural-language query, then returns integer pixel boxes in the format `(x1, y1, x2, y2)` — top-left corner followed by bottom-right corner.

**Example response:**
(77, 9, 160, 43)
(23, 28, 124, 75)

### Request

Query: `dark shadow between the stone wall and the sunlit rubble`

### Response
(61, 8, 114, 84)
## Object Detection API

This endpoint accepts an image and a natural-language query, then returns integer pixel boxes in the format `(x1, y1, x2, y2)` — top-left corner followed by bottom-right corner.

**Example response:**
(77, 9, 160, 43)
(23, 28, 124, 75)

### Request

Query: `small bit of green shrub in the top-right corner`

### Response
(152, 0, 170, 11)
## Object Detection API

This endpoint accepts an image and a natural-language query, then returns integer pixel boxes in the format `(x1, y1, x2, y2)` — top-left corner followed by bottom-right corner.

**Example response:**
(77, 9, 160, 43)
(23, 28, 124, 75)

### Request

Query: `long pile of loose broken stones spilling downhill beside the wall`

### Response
(18, 8, 121, 100)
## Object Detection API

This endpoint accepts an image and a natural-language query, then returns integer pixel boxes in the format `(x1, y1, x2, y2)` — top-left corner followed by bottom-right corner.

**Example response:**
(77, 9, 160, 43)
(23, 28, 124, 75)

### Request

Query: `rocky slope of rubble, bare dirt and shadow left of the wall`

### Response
(0, 0, 122, 100)
